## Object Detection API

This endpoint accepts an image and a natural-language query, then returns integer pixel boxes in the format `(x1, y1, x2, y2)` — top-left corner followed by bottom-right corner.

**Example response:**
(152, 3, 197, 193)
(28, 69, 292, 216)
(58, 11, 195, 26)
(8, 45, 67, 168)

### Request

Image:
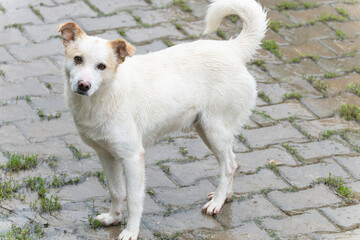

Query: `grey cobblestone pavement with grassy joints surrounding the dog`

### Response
(0, 0, 360, 240)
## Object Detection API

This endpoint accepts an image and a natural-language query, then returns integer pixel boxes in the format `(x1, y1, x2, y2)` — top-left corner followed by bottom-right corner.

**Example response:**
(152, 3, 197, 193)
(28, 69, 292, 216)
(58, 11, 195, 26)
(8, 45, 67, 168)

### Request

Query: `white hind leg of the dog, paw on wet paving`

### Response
(196, 120, 237, 215)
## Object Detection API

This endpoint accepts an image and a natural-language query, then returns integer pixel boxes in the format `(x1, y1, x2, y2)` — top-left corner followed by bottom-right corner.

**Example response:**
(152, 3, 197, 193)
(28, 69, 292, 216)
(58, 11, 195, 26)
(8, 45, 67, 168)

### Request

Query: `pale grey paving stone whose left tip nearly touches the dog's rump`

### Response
(258, 100, 316, 120)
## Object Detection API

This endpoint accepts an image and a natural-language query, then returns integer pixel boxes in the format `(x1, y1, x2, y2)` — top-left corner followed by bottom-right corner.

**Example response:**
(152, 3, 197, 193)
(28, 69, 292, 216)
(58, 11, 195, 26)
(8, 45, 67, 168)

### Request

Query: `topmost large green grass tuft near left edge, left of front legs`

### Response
(1, 153, 38, 172)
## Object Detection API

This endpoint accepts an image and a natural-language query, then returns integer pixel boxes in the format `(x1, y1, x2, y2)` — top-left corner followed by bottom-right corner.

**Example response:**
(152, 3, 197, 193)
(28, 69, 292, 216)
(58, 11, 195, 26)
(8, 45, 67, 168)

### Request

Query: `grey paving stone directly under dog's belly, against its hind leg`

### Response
(175, 137, 212, 158)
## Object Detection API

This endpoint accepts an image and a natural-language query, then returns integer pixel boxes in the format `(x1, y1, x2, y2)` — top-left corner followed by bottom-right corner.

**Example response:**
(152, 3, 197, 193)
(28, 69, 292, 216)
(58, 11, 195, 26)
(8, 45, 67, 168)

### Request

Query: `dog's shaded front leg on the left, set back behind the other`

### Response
(96, 150, 126, 225)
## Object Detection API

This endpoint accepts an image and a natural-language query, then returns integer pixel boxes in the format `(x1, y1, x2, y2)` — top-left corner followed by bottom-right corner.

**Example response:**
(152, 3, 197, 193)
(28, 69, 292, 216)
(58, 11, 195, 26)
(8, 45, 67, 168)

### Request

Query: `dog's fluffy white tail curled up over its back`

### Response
(204, 0, 268, 62)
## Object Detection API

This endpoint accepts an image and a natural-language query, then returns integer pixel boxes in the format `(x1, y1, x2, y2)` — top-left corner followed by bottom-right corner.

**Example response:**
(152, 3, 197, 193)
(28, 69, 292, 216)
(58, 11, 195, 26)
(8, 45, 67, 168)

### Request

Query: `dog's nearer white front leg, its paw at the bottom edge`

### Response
(119, 151, 145, 240)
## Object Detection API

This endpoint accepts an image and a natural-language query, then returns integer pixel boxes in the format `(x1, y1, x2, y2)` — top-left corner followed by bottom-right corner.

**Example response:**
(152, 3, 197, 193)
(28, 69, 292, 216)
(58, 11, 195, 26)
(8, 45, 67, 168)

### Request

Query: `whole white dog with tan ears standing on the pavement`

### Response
(59, 0, 267, 240)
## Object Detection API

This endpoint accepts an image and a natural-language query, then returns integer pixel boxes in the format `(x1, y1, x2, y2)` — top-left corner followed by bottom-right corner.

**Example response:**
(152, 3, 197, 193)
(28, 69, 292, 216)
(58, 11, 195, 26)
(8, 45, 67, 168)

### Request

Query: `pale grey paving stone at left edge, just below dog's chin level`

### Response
(0, 100, 38, 122)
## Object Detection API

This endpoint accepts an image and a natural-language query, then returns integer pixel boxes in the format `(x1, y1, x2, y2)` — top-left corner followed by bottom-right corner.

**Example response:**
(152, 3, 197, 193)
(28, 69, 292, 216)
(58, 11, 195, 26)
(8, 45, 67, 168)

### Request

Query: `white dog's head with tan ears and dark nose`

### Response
(59, 22, 135, 96)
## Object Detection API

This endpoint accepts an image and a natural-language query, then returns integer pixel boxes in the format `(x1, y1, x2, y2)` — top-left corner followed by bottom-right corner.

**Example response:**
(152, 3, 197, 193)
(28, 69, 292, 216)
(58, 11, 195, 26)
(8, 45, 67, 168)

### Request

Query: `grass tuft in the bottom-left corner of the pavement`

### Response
(0, 222, 45, 240)
